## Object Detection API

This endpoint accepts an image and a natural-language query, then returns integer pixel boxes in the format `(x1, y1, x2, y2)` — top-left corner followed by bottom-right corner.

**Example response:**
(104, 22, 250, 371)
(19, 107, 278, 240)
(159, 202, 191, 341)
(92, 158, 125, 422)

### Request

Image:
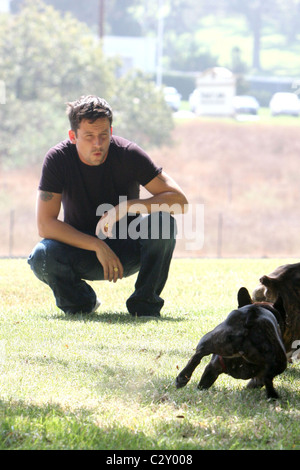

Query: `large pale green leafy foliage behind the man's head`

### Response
(0, 0, 172, 166)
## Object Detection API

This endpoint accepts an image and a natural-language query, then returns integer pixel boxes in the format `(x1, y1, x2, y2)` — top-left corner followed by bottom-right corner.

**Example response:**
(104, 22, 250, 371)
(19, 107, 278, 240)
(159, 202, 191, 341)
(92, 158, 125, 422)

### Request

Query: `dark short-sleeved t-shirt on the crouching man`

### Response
(39, 136, 162, 232)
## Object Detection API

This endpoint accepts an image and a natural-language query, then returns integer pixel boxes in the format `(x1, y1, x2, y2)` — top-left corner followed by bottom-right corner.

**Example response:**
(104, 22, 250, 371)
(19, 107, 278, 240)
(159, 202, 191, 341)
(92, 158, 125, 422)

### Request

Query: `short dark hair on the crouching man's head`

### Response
(67, 95, 113, 133)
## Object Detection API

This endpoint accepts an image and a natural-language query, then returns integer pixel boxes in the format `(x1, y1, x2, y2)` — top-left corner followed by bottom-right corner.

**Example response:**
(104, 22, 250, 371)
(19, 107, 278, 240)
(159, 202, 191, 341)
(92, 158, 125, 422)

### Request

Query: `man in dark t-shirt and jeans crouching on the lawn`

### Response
(28, 96, 187, 317)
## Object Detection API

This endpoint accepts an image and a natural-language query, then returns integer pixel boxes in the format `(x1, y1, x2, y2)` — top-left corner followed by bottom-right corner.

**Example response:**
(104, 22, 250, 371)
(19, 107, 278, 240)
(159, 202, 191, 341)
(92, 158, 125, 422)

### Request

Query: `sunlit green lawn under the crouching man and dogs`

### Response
(0, 259, 300, 450)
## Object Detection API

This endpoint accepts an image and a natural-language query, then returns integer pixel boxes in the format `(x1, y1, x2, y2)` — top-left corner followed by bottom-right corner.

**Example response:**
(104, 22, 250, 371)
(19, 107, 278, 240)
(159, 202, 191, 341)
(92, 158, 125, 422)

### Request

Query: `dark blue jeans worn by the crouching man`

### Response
(28, 212, 176, 315)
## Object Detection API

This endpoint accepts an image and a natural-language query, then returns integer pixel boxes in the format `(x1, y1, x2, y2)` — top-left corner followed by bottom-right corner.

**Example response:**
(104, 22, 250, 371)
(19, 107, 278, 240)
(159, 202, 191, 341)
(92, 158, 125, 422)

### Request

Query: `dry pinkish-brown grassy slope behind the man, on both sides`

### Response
(0, 119, 300, 257)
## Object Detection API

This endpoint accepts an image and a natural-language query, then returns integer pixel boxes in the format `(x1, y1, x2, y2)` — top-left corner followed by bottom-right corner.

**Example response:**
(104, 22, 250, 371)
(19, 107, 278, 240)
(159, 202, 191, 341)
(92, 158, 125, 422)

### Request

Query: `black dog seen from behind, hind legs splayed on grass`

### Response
(176, 287, 287, 398)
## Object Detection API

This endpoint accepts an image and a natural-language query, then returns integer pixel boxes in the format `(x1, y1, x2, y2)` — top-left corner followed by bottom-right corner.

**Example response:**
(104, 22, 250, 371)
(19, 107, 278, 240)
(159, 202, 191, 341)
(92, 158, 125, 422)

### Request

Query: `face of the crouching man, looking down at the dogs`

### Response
(69, 118, 112, 166)
